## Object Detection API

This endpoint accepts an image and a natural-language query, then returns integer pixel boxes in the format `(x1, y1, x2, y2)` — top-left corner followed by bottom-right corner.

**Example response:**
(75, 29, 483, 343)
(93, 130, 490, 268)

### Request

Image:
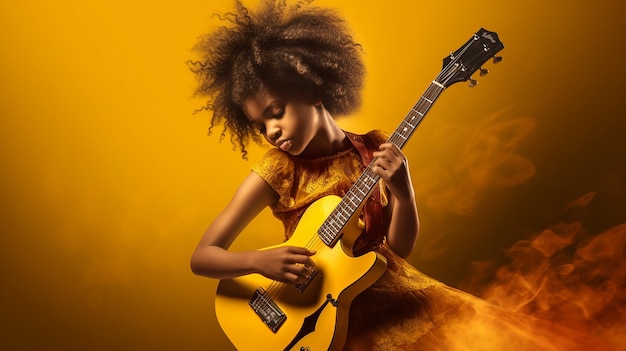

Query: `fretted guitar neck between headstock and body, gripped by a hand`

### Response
(318, 81, 445, 247)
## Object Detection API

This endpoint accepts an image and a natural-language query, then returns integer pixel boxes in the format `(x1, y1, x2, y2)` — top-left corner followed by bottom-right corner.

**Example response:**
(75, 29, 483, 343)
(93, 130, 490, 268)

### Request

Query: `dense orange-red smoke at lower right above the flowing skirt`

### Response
(461, 193, 626, 349)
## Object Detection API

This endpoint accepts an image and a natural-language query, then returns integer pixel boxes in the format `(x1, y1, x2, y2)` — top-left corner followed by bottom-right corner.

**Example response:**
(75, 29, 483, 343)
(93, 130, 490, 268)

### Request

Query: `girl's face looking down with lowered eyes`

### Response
(243, 91, 321, 156)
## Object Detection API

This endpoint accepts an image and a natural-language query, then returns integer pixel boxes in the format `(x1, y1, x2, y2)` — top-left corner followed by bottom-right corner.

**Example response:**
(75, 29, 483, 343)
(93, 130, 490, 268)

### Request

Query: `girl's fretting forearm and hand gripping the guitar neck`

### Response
(373, 143, 419, 258)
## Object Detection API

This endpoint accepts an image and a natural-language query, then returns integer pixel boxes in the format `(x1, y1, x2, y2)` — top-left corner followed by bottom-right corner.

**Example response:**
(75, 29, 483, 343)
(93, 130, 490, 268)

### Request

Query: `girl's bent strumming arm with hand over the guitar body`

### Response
(191, 172, 314, 283)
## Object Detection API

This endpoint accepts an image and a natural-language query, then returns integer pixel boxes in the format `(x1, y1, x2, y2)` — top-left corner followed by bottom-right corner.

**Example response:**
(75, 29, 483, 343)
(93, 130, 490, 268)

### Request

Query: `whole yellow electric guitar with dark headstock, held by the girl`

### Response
(215, 28, 504, 351)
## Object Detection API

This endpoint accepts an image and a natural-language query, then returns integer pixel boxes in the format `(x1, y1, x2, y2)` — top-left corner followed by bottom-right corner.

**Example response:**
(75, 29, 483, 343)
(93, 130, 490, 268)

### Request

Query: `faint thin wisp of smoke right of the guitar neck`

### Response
(414, 106, 536, 215)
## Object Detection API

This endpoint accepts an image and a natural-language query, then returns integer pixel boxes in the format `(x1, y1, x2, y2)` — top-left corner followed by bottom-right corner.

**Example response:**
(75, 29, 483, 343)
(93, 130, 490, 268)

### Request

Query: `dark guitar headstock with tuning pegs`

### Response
(435, 28, 504, 88)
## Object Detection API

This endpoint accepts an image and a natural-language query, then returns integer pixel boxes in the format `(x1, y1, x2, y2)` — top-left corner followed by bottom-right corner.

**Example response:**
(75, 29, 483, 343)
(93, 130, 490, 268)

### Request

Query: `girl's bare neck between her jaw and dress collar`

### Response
(300, 105, 350, 158)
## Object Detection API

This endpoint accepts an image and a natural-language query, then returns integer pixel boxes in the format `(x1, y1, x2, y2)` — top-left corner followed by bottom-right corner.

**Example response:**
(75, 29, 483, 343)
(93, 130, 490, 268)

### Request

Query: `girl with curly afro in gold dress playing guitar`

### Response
(191, 1, 608, 350)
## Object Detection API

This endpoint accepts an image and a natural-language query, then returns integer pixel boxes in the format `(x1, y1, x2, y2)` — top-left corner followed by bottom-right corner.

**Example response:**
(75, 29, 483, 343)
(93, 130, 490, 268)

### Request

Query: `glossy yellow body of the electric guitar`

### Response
(215, 196, 387, 351)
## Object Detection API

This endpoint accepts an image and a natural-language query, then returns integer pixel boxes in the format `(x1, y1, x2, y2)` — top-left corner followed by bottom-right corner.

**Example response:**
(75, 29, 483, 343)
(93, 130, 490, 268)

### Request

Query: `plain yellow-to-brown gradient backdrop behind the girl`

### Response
(0, 0, 626, 350)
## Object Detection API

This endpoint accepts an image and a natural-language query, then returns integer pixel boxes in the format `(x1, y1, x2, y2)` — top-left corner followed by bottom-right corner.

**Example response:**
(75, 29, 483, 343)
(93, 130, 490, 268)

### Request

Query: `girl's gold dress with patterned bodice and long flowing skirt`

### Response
(252, 131, 608, 351)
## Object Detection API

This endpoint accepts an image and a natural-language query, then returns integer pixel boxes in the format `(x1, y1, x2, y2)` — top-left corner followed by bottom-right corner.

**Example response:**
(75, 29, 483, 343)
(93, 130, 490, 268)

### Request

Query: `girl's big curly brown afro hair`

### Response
(189, 0, 365, 158)
